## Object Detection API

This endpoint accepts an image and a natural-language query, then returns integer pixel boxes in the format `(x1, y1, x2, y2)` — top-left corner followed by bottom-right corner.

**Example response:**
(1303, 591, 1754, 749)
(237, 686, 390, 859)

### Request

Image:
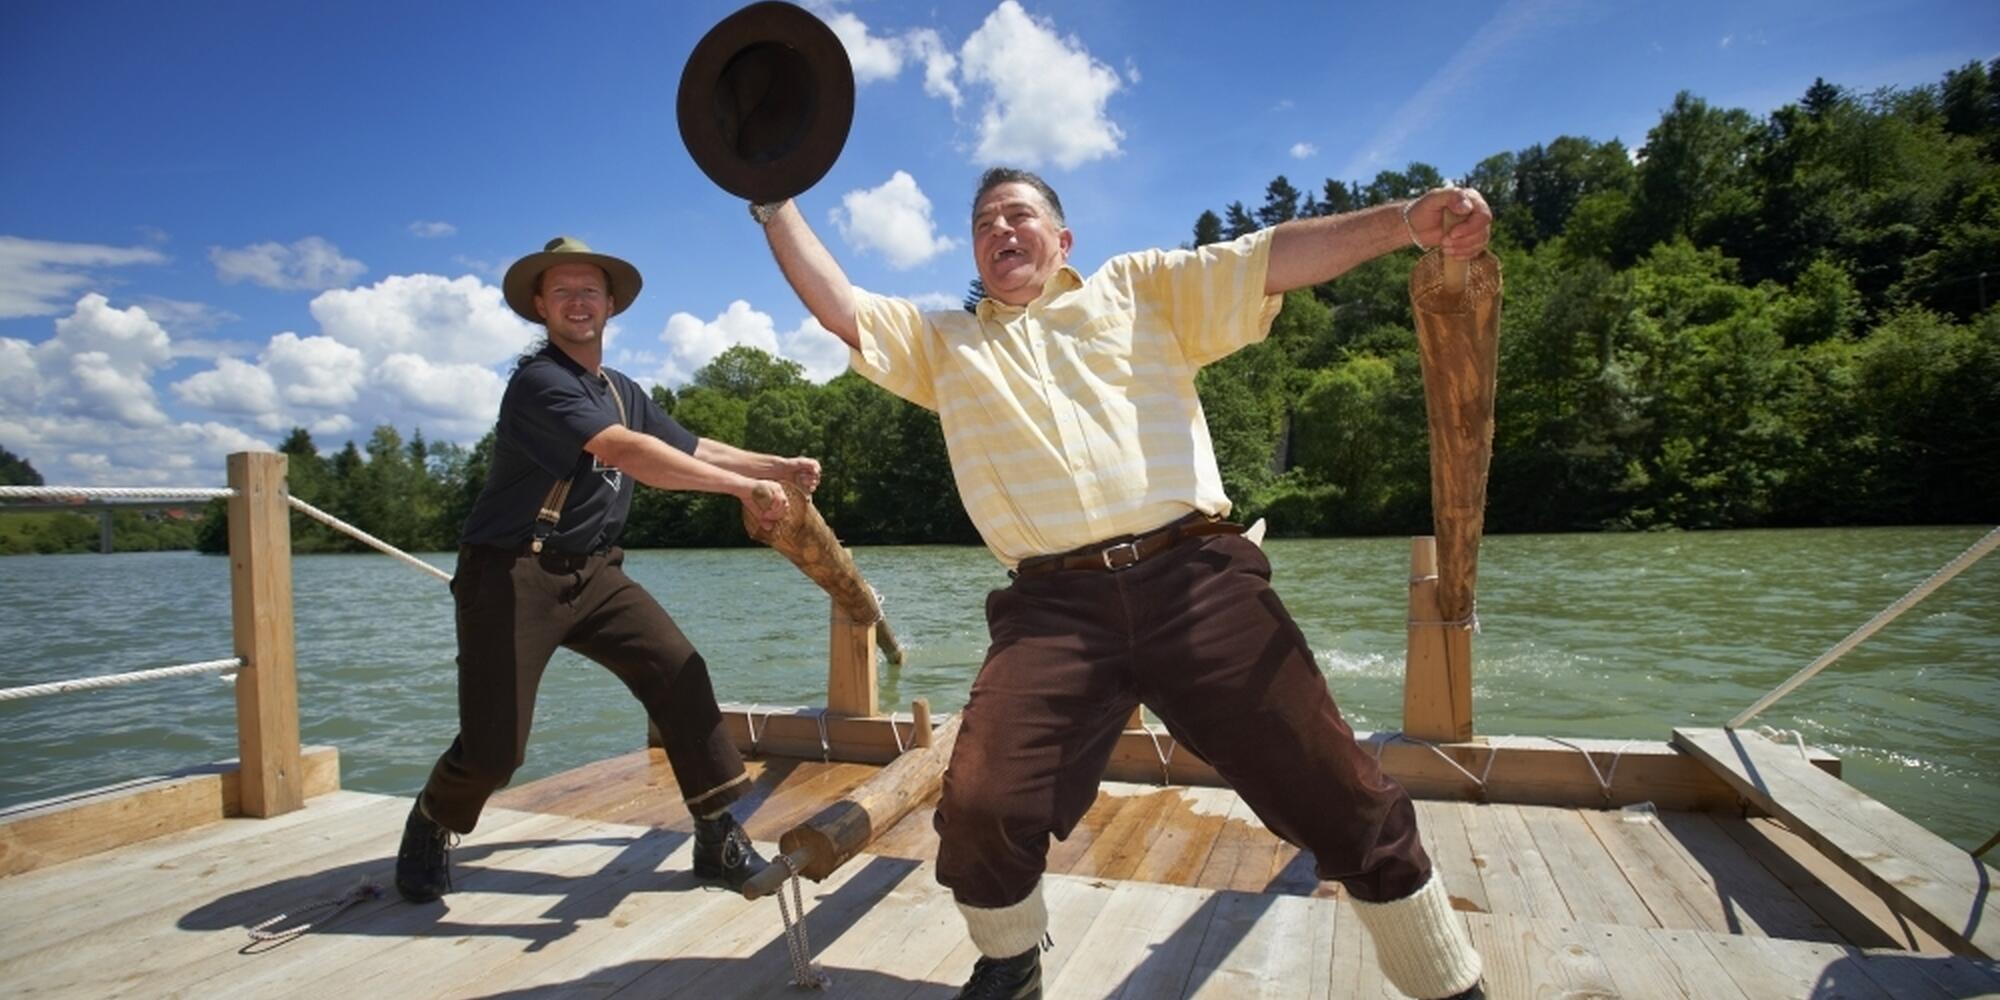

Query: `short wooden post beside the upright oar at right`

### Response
(1402, 536, 1472, 742)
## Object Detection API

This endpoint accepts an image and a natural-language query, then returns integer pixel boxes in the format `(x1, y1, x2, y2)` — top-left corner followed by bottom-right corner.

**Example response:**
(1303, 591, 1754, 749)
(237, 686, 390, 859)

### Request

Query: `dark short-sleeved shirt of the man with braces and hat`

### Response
(460, 346, 698, 554)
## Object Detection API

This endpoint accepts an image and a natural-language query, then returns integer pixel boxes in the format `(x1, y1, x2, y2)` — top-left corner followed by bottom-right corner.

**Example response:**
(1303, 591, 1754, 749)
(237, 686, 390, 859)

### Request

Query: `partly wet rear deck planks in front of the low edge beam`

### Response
(494, 752, 1946, 954)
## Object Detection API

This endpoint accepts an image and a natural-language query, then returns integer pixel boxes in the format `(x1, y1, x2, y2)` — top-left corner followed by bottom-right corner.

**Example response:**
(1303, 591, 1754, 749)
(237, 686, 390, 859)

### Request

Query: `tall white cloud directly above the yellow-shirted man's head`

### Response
(960, 0, 1124, 170)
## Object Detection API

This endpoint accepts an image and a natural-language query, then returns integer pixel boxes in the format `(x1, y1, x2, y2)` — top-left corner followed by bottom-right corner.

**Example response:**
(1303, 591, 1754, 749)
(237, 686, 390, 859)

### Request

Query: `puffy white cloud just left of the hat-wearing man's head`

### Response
(310, 274, 536, 364)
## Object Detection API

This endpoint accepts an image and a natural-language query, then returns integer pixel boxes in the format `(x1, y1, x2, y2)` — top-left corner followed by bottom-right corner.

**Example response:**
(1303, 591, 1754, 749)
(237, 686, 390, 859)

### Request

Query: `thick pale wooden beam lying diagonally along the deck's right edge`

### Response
(1674, 728, 2000, 958)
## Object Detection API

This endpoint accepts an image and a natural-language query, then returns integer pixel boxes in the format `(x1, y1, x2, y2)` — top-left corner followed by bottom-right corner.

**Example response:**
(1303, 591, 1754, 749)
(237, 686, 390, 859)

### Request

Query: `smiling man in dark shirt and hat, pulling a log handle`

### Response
(396, 238, 820, 902)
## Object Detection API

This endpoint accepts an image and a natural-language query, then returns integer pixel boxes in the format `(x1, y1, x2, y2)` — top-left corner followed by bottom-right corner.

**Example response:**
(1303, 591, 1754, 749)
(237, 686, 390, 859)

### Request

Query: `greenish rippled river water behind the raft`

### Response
(0, 528, 2000, 848)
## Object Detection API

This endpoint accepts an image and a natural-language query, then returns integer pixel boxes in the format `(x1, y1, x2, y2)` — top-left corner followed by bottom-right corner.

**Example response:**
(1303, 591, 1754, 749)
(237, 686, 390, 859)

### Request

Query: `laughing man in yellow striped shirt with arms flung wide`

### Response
(752, 168, 1492, 998)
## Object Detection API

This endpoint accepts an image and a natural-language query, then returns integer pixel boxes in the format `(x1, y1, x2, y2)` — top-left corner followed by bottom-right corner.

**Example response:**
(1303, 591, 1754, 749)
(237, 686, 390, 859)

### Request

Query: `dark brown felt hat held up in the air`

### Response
(680, 0, 854, 202)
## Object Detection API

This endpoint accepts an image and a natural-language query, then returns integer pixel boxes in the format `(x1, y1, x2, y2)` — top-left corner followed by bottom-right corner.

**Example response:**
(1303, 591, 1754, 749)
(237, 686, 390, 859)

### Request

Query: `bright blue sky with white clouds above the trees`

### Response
(0, 0, 2000, 486)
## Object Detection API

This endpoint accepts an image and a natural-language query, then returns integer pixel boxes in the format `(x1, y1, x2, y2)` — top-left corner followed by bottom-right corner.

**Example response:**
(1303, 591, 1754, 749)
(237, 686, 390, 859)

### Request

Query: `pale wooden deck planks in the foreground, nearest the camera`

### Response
(0, 788, 2000, 1000)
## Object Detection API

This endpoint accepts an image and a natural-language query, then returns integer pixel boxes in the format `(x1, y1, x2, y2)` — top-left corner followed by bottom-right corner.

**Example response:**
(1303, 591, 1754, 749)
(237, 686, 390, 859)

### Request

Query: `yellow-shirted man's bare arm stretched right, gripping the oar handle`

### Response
(1264, 188, 1494, 296)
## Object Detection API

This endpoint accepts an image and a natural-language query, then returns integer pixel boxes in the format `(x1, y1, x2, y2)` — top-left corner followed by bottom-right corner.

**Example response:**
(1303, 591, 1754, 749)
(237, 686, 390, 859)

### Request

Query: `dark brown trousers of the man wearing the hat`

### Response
(422, 546, 748, 834)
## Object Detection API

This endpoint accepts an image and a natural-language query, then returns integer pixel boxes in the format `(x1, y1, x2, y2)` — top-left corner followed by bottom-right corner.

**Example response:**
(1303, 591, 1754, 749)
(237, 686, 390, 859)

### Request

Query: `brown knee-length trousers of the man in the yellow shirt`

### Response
(936, 534, 1430, 908)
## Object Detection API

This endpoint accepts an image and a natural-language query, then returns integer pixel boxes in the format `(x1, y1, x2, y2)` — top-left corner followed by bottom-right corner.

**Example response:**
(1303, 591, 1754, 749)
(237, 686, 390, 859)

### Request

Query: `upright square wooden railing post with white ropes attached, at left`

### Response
(228, 452, 306, 816)
